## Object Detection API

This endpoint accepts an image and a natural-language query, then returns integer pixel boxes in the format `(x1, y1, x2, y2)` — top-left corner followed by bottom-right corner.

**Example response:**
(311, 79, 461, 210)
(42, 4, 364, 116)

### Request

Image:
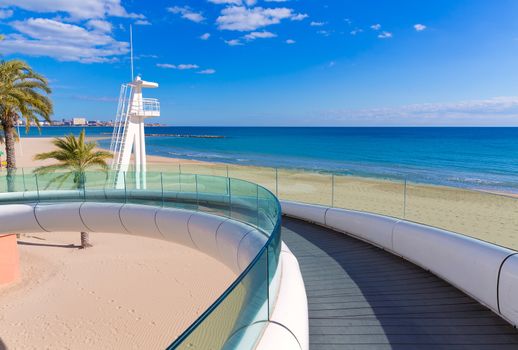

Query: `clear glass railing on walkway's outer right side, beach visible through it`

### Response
(150, 163, 518, 250)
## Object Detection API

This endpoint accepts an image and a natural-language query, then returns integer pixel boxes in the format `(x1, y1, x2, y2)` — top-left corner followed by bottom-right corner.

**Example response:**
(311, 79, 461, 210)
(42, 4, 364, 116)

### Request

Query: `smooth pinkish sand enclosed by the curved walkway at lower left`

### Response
(0, 232, 236, 349)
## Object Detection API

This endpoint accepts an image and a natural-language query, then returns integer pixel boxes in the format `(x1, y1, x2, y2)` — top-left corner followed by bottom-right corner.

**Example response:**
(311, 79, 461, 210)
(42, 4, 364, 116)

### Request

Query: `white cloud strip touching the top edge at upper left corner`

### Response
(0, 0, 144, 19)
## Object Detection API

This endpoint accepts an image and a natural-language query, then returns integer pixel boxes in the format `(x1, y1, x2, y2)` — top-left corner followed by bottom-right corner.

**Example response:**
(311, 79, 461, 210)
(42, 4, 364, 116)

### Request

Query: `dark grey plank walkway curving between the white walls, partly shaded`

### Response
(282, 217, 518, 350)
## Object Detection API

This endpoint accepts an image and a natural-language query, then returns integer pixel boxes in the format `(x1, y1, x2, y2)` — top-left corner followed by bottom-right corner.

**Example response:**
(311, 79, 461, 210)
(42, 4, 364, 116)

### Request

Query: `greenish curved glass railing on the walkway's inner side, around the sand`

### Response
(0, 169, 281, 349)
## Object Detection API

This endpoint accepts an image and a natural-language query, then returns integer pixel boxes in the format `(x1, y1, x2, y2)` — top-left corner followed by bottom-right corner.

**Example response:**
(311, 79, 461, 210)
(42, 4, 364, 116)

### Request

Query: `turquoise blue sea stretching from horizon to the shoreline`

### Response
(22, 127, 518, 193)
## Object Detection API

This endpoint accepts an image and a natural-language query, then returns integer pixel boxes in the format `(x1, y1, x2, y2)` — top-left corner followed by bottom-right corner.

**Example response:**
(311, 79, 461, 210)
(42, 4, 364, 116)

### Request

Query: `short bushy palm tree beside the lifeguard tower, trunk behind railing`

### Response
(34, 129, 112, 248)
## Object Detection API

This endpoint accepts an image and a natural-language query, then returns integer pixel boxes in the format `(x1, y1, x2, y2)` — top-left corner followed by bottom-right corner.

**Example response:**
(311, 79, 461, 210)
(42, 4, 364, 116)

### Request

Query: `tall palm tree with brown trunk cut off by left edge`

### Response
(0, 60, 52, 191)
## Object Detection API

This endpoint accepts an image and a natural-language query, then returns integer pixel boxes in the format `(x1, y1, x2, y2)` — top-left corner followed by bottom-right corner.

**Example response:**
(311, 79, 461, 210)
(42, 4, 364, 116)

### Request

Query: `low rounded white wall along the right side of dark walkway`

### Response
(281, 201, 518, 326)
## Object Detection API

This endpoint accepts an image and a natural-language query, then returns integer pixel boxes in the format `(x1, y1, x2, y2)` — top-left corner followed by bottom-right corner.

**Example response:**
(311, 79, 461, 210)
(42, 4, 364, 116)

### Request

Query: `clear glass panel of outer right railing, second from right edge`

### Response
(334, 175, 405, 218)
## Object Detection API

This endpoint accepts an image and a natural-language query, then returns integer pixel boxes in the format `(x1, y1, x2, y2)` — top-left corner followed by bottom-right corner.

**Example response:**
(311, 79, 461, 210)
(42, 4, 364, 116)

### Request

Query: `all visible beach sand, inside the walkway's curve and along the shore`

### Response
(0, 138, 518, 349)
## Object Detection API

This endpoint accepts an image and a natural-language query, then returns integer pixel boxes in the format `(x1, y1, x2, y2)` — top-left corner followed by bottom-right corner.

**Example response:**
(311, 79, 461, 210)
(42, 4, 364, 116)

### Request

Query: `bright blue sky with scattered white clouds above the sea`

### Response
(0, 0, 518, 126)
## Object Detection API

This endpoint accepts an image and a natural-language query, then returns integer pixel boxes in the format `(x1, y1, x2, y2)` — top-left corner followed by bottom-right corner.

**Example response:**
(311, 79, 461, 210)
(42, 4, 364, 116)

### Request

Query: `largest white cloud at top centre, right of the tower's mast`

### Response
(216, 6, 300, 31)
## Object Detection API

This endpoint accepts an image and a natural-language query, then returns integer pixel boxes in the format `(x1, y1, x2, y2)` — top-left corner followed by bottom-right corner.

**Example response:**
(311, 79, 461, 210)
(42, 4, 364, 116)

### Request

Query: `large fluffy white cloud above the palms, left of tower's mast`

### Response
(0, 18, 128, 63)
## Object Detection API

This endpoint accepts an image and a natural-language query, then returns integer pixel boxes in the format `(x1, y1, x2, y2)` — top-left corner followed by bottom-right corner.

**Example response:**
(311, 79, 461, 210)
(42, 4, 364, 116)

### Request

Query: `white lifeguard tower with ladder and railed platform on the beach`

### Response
(110, 76, 160, 189)
